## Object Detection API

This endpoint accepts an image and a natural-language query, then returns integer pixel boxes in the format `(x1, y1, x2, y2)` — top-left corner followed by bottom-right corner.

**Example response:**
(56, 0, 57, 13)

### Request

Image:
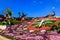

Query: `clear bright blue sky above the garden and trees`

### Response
(0, 0, 60, 17)
